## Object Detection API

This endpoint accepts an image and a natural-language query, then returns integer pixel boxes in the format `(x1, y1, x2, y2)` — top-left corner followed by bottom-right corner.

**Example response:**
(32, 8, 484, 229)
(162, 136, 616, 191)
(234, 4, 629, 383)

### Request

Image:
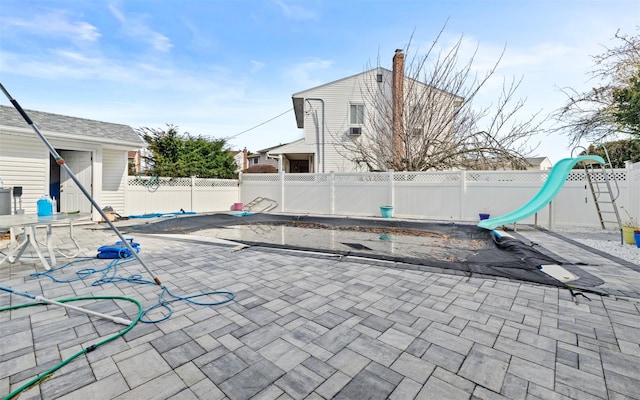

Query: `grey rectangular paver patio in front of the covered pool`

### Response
(0, 220, 640, 400)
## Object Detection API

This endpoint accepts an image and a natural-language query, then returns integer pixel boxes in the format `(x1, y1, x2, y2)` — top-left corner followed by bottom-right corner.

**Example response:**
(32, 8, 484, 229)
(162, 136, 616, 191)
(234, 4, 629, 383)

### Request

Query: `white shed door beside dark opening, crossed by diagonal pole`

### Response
(60, 150, 93, 213)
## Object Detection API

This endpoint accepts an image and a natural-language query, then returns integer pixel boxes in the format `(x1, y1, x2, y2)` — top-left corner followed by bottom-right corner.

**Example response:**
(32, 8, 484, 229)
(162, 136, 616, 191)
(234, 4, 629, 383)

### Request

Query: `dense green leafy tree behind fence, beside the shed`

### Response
(138, 124, 237, 178)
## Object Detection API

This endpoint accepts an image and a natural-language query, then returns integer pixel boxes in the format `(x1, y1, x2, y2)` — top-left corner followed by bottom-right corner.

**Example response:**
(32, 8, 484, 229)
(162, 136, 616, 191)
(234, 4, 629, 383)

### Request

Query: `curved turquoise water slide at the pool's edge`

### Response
(478, 156, 605, 229)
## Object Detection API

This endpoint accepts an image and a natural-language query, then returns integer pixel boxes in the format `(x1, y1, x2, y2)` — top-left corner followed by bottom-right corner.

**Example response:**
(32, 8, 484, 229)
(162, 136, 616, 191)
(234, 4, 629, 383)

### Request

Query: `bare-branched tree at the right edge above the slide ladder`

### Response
(554, 31, 640, 145)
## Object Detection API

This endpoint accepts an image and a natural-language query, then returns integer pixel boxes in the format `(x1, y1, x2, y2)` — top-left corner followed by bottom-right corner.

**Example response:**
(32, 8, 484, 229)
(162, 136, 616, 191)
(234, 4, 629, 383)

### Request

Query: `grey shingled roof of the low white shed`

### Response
(0, 105, 144, 147)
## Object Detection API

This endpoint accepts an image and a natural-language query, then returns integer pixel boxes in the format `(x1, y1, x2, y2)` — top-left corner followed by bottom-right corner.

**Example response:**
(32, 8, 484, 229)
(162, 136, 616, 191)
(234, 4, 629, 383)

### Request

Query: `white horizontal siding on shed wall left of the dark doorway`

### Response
(0, 133, 49, 213)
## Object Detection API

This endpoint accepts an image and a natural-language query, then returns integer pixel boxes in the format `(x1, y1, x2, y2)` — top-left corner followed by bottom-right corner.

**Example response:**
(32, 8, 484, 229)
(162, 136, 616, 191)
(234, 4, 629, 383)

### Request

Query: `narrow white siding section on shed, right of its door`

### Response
(100, 149, 127, 215)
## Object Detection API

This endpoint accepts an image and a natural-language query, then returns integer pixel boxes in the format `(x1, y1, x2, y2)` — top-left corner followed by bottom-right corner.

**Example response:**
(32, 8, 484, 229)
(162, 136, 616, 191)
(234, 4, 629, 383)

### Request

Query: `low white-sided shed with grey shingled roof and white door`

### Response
(0, 105, 144, 220)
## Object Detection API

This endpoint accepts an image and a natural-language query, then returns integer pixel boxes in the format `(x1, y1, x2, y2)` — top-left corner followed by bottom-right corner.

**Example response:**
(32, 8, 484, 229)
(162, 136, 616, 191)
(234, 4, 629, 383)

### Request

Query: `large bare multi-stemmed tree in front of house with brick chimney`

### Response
(338, 27, 543, 171)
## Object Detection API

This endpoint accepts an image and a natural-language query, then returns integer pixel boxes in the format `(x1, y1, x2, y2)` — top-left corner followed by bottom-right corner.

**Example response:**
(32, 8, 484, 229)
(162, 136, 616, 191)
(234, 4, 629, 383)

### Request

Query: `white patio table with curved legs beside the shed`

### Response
(0, 213, 91, 270)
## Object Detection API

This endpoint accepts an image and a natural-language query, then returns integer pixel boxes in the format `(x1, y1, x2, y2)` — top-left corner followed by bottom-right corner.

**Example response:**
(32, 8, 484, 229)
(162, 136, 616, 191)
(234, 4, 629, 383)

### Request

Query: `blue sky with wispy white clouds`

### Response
(0, 0, 640, 163)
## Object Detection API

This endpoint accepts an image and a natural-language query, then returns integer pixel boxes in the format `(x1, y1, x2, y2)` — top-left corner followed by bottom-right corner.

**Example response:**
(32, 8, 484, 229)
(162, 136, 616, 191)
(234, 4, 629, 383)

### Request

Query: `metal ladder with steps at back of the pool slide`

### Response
(584, 148, 622, 230)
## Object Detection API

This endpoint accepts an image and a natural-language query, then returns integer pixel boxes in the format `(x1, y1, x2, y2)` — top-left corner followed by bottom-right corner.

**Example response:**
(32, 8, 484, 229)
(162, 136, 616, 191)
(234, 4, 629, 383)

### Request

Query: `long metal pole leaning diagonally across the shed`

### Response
(0, 83, 162, 286)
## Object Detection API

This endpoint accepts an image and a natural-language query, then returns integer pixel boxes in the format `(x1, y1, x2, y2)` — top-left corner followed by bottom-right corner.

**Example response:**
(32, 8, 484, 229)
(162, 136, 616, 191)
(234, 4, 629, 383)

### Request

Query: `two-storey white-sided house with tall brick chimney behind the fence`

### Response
(268, 50, 463, 173)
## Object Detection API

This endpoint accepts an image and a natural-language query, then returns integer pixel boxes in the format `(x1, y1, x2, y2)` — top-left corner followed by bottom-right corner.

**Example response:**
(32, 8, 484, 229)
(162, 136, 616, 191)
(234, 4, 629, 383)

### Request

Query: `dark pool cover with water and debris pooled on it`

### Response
(121, 213, 565, 287)
